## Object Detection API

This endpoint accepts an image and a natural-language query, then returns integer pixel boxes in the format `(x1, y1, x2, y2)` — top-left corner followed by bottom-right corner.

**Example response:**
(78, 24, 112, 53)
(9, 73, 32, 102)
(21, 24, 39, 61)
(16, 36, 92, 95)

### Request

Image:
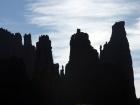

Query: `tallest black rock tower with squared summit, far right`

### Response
(100, 21, 136, 105)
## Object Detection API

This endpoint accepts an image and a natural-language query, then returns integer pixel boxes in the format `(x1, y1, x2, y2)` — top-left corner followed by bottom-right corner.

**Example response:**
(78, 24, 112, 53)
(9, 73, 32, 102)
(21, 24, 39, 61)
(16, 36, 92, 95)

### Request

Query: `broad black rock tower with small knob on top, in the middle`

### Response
(66, 29, 99, 104)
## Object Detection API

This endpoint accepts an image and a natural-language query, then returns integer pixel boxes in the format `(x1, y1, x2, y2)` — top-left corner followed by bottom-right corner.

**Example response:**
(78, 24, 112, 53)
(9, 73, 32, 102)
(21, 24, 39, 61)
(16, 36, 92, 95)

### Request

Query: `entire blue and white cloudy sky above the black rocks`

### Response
(0, 0, 140, 97)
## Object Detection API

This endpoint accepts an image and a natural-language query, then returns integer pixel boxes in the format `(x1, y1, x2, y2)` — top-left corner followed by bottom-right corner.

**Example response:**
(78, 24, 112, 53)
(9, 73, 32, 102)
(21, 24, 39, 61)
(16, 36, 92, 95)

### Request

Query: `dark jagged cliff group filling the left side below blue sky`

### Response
(0, 28, 59, 105)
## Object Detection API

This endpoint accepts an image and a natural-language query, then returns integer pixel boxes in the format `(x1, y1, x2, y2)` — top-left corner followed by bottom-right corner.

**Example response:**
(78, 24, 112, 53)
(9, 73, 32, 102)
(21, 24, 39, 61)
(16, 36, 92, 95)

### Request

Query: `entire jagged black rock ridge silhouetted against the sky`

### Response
(0, 21, 139, 105)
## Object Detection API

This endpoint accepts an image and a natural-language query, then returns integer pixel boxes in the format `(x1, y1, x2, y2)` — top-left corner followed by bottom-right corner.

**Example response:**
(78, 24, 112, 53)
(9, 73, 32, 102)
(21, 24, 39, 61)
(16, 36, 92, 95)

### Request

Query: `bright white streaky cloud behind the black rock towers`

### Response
(25, 0, 140, 96)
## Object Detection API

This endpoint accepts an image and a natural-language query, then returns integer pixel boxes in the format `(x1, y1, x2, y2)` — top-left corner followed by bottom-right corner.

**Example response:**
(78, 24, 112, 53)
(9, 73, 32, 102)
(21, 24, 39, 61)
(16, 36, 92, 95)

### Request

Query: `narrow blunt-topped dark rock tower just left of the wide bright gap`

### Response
(36, 35, 53, 76)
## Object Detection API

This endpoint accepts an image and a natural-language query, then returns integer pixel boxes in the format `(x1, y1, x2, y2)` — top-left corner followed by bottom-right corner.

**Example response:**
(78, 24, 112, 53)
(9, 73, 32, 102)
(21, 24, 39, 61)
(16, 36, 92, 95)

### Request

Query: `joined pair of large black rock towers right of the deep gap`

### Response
(65, 21, 136, 105)
